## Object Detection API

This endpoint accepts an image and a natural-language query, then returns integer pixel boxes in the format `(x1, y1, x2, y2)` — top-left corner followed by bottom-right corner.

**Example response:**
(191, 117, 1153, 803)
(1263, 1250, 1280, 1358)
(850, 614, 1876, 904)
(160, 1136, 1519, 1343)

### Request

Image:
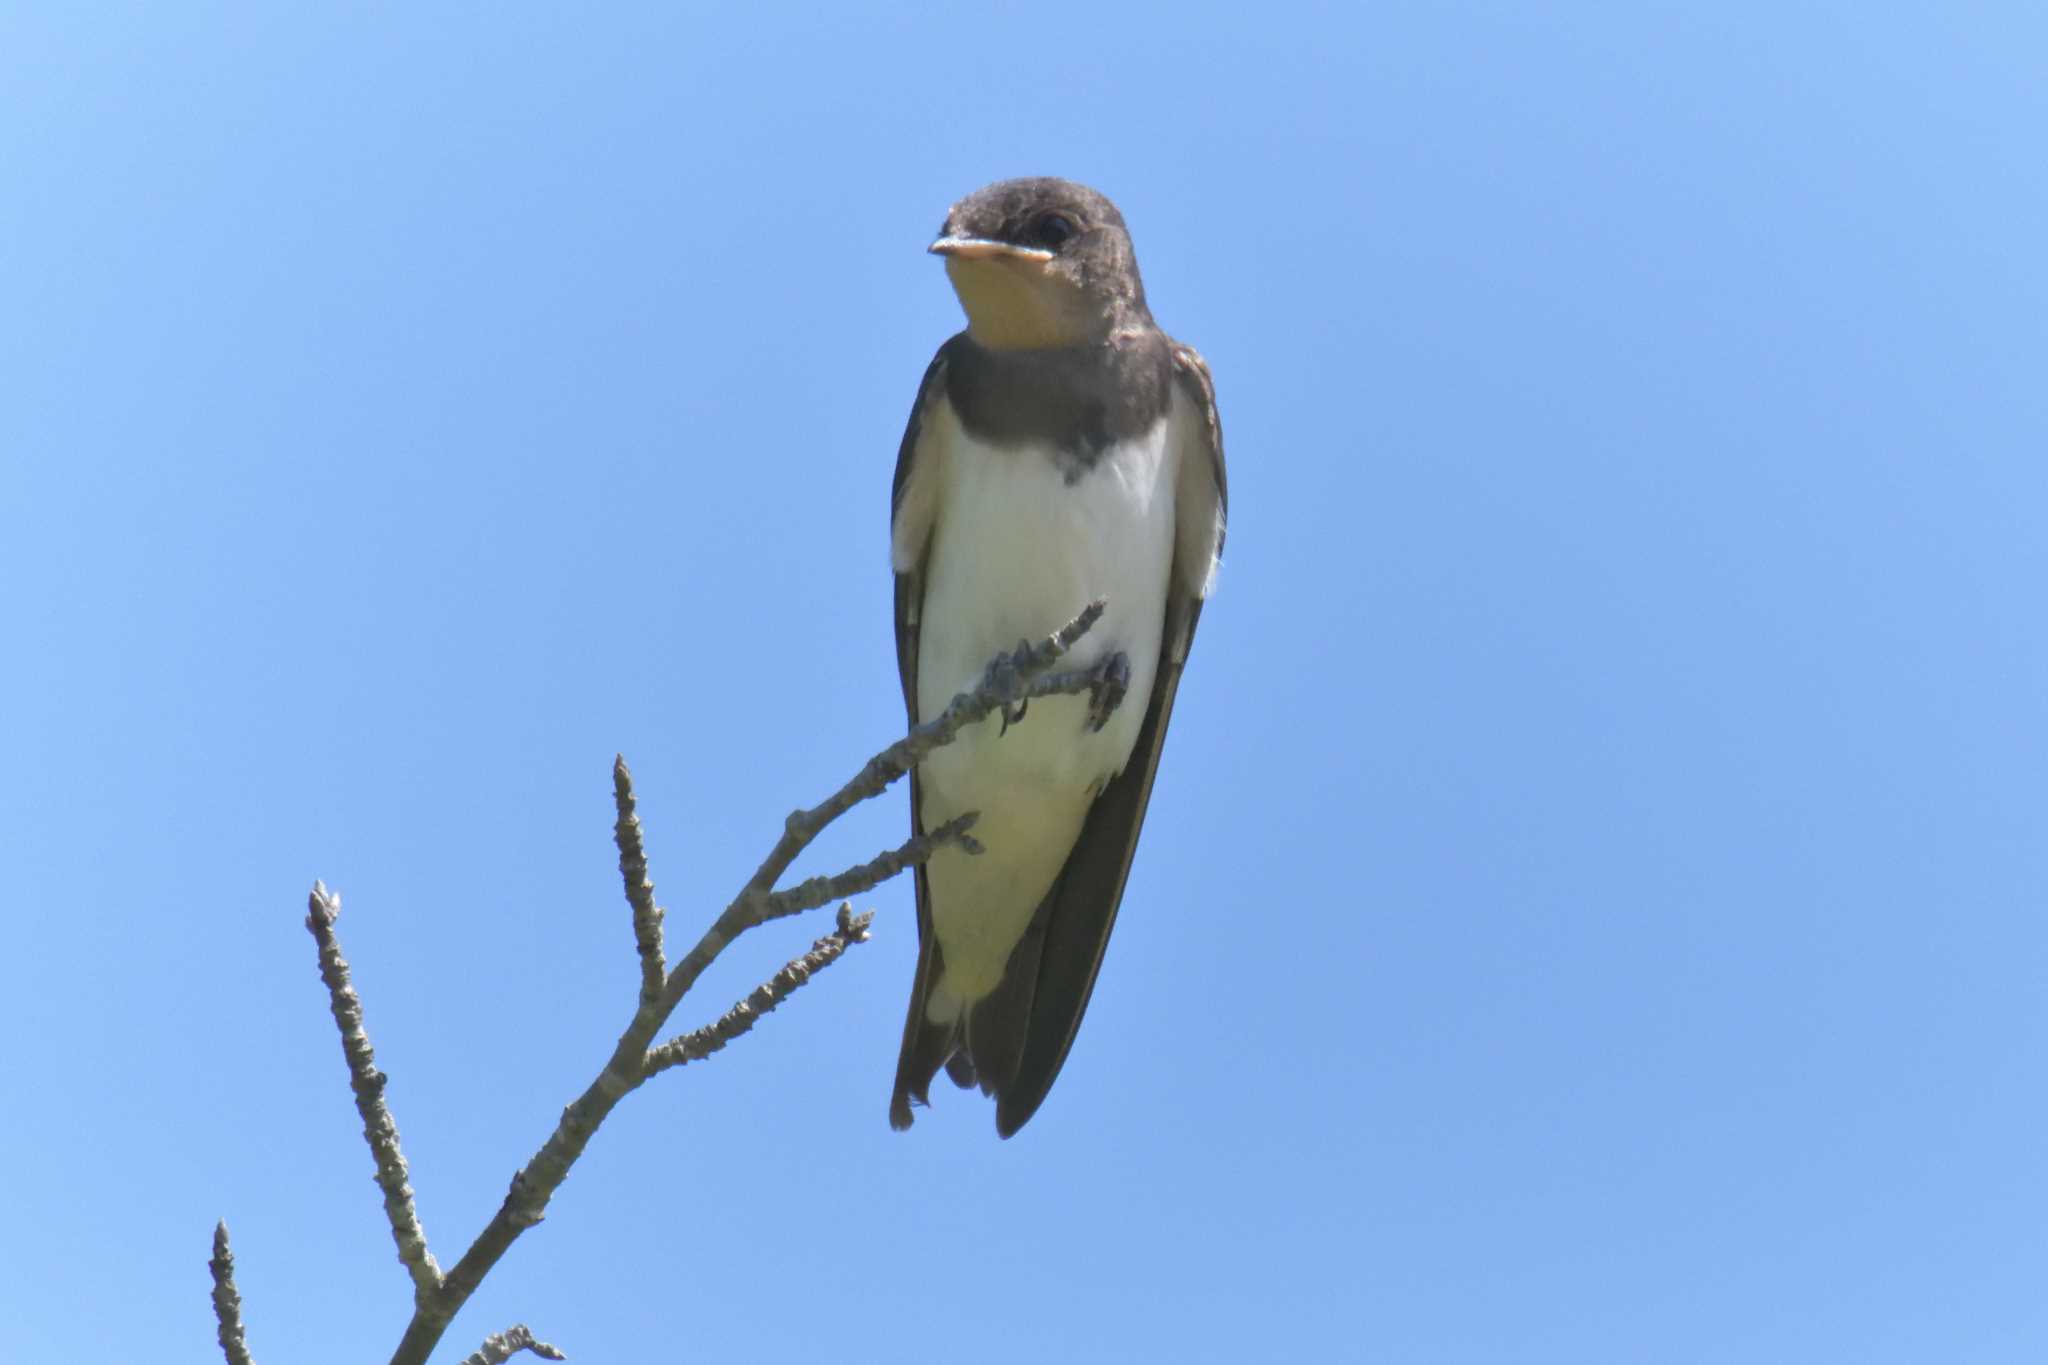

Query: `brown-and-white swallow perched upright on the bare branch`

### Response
(889, 178, 1225, 1138)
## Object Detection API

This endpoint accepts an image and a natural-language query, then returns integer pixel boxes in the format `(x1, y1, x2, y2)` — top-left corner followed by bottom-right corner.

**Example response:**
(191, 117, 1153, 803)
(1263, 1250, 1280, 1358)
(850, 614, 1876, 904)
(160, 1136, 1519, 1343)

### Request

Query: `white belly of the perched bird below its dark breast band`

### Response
(918, 411, 1176, 1002)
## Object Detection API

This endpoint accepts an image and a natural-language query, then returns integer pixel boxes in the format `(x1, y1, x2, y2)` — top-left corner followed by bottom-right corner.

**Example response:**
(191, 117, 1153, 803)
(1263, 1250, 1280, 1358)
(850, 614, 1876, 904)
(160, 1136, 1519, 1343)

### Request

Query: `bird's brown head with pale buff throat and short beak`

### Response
(930, 176, 1151, 350)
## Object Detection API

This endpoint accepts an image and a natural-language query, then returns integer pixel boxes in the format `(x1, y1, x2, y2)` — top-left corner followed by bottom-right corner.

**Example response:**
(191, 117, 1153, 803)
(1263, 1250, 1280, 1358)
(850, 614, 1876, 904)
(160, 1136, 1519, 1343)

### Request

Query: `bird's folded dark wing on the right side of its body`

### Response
(995, 344, 1227, 1138)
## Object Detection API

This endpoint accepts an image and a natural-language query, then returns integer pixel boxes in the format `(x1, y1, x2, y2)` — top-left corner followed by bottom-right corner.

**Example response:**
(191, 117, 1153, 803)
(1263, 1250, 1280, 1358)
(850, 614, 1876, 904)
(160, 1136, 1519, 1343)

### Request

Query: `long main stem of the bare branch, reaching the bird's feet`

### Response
(374, 602, 1104, 1365)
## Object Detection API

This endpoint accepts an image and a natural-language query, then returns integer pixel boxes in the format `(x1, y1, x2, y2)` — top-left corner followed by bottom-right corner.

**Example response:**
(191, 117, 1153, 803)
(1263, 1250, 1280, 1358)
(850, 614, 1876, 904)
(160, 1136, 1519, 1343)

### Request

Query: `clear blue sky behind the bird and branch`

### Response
(0, 2, 2048, 1365)
